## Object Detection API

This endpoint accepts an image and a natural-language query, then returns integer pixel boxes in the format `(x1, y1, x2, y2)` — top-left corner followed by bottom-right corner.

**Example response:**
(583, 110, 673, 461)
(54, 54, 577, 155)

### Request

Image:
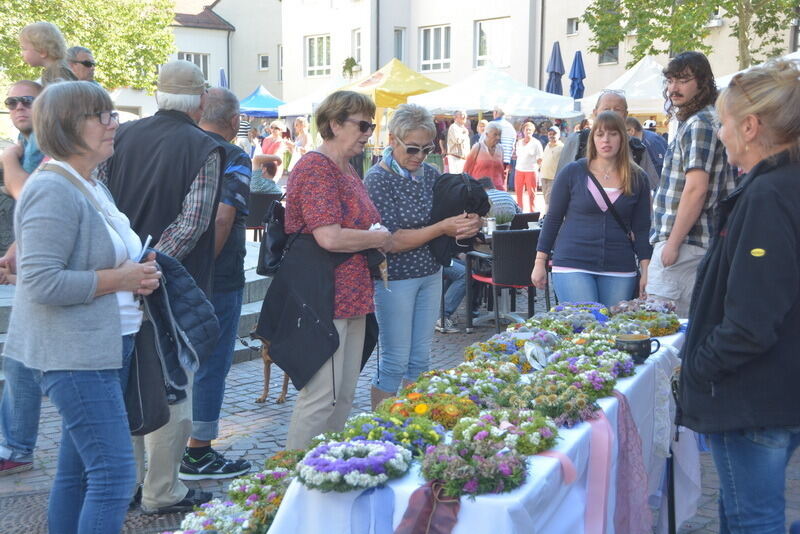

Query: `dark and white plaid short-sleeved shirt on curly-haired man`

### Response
(650, 106, 734, 248)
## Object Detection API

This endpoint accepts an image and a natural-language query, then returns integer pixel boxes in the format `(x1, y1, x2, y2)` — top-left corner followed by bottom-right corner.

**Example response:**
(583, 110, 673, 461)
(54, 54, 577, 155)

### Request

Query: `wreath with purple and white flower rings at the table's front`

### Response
(297, 440, 411, 492)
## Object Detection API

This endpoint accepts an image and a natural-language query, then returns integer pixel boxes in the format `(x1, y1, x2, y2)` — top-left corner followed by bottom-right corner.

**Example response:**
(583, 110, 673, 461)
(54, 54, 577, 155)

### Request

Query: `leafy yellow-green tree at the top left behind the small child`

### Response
(0, 0, 175, 90)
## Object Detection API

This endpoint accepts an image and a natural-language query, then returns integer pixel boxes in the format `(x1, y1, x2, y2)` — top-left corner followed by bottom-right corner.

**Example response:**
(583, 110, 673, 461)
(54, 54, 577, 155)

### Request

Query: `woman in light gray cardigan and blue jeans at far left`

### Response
(4, 82, 161, 534)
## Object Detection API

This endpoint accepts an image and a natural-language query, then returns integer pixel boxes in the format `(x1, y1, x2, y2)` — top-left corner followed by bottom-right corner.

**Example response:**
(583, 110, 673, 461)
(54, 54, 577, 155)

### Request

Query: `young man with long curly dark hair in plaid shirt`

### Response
(647, 52, 734, 317)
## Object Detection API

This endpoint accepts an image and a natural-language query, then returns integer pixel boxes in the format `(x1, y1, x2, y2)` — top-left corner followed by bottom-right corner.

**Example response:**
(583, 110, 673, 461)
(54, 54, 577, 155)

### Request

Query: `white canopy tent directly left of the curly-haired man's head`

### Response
(581, 56, 664, 115)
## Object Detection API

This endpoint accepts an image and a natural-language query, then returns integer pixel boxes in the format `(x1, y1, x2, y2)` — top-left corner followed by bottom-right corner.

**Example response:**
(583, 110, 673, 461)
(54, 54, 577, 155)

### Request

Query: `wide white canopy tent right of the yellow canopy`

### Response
(408, 69, 581, 119)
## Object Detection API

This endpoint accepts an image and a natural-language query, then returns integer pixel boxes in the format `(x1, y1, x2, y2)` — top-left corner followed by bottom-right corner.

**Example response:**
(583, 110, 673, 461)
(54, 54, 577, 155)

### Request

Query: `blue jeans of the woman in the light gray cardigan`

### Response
(40, 336, 136, 534)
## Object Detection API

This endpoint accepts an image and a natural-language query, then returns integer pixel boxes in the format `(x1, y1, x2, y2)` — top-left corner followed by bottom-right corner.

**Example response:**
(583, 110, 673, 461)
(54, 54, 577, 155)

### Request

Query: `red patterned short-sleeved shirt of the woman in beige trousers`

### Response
(286, 152, 381, 319)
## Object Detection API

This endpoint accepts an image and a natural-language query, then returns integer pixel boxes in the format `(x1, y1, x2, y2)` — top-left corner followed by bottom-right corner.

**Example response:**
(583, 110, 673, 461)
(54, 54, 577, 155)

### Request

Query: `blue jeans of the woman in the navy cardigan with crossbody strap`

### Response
(553, 273, 636, 306)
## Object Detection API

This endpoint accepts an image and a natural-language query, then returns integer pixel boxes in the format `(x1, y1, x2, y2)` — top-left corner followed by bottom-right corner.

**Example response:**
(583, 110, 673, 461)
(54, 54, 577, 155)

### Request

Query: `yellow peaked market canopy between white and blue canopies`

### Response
(341, 58, 447, 108)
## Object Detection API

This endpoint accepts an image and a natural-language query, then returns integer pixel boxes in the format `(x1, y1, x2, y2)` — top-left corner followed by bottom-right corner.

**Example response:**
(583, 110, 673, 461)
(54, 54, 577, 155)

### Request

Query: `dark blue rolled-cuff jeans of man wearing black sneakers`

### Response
(192, 289, 244, 441)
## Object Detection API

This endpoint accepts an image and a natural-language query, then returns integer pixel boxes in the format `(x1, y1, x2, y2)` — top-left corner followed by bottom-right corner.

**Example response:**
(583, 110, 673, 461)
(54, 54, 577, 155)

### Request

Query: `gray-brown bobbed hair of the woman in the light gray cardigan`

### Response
(33, 82, 114, 160)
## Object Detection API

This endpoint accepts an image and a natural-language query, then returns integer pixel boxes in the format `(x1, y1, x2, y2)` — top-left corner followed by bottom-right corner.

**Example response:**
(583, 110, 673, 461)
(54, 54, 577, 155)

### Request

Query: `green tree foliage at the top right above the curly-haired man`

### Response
(583, 0, 797, 69)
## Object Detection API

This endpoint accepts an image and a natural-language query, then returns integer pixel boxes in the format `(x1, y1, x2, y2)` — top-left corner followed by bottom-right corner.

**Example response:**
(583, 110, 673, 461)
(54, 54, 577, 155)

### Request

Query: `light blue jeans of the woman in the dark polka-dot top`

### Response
(372, 271, 442, 393)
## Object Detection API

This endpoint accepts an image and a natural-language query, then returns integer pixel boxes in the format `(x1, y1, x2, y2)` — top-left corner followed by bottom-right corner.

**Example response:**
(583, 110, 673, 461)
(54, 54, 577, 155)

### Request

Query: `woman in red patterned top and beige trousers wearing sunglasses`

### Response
(286, 91, 391, 449)
